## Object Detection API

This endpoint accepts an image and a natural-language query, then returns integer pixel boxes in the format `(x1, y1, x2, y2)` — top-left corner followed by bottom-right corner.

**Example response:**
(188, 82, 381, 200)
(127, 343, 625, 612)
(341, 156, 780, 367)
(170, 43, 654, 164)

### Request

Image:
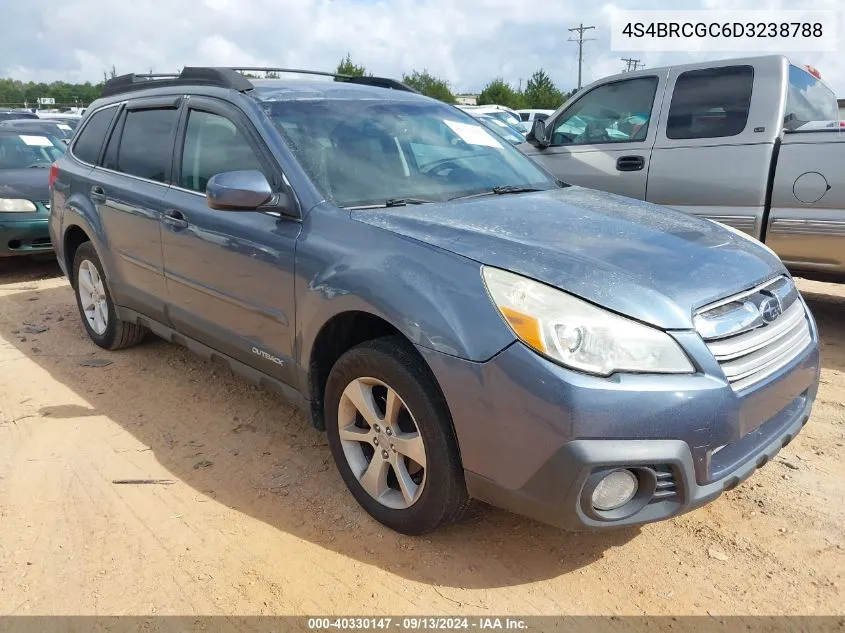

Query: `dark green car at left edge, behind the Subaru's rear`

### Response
(0, 127, 66, 257)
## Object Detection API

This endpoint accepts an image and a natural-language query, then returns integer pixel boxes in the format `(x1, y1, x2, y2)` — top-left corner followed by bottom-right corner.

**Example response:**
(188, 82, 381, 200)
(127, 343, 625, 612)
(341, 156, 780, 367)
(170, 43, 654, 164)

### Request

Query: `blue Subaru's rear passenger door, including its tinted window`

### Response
(89, 97, 180, 322)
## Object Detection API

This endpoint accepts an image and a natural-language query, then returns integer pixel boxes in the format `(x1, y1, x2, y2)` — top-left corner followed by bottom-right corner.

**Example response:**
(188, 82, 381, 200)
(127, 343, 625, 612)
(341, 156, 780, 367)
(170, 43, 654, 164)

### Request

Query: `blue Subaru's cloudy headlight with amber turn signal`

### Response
(481, 266, 695, 376)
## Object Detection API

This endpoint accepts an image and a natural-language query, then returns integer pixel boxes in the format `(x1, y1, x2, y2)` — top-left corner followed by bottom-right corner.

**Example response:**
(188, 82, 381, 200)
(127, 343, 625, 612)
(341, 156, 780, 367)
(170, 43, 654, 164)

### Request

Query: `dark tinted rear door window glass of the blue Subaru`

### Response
(112, 108, 178, 182)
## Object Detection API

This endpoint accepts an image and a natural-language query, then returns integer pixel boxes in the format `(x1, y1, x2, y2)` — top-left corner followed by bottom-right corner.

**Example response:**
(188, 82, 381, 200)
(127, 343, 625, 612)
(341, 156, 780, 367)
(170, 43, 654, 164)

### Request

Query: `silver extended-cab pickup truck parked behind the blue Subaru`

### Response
(519, 55, 845, 281)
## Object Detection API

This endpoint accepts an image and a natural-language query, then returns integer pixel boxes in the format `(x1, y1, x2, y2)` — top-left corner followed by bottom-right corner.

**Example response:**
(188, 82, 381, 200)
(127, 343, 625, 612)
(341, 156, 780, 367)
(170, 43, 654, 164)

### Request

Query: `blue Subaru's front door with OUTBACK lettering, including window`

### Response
(162, 98, 301, 384)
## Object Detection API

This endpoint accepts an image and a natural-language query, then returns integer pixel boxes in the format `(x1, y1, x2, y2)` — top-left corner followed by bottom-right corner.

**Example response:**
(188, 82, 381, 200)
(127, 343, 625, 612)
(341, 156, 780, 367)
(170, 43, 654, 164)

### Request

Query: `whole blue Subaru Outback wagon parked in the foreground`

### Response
(50, 67, 819, 534)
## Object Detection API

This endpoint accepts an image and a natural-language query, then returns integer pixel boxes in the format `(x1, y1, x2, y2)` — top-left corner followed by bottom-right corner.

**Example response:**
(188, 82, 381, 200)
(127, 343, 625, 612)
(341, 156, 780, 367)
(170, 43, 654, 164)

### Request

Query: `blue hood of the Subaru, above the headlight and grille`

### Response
(352, 186, 785, 329)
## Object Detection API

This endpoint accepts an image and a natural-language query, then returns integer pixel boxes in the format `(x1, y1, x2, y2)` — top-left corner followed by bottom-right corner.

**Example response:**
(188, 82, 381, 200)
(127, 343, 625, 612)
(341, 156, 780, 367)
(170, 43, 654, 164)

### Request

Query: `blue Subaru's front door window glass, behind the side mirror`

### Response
(179, 110, 264, 193)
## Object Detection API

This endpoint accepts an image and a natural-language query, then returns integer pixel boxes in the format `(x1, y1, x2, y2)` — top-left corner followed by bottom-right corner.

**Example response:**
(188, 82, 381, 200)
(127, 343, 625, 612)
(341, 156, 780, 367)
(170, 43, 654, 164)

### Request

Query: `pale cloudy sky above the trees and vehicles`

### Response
(0, 0, 845, 97)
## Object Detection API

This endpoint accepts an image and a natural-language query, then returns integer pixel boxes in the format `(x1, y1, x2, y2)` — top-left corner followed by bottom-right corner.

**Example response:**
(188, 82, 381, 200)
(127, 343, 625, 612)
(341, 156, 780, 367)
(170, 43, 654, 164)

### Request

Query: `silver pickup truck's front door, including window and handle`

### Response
(522, 73, 665, 200)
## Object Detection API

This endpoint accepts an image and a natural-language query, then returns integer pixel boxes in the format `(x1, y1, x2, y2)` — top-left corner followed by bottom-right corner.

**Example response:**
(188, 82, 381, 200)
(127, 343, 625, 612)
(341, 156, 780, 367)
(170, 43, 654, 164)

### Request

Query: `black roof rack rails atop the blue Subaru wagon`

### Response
(103, 66, 419, 97)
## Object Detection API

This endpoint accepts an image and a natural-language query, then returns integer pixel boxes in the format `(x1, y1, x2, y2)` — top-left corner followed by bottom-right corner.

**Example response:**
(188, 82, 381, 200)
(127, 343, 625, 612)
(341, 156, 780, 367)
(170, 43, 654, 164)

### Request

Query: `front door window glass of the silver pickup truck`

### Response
(552, 77, 658, 145)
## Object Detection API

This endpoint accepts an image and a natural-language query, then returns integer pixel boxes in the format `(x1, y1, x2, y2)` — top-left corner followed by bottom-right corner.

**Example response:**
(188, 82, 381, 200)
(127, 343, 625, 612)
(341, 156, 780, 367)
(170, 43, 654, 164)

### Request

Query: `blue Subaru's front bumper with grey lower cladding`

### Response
(420, 306, 819, 529)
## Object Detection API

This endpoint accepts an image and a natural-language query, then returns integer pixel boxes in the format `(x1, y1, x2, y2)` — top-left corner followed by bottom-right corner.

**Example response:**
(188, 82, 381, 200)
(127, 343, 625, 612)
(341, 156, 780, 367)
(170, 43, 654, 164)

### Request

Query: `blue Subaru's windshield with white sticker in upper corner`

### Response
(263, 99, 557, 207)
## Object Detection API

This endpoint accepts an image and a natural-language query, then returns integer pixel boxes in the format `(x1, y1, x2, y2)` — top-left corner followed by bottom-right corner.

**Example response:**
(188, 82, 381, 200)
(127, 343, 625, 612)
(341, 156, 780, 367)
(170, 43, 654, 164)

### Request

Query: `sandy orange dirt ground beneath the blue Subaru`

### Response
(0, 259, 845, 615)
